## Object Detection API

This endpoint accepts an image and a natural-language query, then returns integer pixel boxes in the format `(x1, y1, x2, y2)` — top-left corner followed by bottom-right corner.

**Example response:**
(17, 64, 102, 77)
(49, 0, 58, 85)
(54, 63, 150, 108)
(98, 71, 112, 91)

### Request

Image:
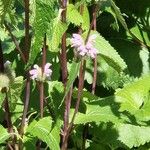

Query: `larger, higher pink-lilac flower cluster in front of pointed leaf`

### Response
(71, 34, 97, 58)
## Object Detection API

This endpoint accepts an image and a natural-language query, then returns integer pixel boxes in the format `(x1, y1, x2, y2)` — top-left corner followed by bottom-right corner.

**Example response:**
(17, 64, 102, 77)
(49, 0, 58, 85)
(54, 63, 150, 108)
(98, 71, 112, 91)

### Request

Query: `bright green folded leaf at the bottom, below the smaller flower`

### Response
(26, 117, 60, 150)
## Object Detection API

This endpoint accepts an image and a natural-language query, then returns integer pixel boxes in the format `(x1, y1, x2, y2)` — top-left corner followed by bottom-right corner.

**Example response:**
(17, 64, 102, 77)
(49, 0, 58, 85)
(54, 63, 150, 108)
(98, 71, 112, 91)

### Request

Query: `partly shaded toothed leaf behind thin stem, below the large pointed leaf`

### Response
(85, 56, 133, 89)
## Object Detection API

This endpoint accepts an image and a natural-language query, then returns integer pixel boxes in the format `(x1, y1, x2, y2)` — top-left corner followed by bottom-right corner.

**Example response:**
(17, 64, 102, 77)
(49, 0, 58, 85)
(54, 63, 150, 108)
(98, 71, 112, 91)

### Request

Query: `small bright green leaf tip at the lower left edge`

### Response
(0, 125, 11, 144)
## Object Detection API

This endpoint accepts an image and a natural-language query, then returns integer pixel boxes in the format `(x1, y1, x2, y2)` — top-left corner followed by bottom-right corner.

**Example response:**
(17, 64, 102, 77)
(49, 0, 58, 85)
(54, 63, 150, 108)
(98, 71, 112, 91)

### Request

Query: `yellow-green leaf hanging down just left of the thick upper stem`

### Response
(49, 18, 67, 52)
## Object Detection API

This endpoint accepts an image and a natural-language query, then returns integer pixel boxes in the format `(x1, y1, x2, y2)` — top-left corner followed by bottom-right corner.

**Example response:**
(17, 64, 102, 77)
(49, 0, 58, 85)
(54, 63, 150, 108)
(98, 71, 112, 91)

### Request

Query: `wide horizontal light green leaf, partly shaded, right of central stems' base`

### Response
(74, 97, 121, 124)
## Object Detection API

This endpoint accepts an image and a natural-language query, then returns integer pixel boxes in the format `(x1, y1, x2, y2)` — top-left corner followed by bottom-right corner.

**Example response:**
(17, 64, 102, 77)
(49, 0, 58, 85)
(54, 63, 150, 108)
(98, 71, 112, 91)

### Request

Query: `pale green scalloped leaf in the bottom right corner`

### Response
(116, 124, 150, 149)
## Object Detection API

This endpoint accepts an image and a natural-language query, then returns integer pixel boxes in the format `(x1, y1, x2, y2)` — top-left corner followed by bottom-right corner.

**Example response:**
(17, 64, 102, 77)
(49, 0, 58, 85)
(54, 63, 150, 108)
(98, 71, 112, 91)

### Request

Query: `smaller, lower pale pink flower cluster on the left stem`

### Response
(29, 63, 52, 81)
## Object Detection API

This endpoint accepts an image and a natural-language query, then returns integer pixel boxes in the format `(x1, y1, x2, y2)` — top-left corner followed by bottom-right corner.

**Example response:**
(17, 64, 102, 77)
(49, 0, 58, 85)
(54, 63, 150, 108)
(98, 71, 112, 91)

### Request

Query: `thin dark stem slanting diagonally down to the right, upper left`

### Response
(4, 22, 26, 63)
